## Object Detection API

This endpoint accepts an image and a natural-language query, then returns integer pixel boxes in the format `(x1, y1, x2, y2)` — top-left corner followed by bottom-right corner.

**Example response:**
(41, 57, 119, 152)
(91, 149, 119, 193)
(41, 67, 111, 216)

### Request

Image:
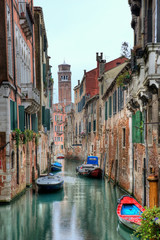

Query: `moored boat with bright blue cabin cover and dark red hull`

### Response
(76, 156, 102, 178)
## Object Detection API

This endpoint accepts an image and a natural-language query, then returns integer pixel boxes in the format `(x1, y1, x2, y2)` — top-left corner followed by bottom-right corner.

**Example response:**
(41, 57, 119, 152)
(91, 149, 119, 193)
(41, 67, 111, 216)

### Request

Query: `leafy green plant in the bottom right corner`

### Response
(134, 207, 160, 240)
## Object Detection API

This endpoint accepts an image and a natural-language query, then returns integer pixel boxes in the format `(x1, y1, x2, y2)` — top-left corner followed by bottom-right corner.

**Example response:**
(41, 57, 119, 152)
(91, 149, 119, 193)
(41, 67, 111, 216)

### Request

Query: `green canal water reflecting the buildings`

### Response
(0, 160, 137, 240)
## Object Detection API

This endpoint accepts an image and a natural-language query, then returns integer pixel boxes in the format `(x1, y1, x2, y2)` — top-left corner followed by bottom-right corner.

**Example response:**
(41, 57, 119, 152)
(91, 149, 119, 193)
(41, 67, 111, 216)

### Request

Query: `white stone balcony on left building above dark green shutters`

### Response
(21, 83, 40, 114)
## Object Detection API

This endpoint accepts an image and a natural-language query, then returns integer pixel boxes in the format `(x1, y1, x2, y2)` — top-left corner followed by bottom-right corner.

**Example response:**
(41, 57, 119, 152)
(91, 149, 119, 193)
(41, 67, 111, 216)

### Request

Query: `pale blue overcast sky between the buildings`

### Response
(34, 0, 133, 103)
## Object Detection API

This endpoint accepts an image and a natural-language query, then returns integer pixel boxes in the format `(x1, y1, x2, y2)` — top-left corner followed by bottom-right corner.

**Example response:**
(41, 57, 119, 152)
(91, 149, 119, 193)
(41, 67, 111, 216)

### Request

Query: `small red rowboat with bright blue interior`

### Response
(117, 196, 145, 230)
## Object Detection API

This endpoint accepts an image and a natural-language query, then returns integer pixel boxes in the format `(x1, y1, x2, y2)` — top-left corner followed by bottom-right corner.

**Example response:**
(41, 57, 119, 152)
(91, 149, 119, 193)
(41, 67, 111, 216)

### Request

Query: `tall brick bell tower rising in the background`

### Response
(58, 62, 71, 105)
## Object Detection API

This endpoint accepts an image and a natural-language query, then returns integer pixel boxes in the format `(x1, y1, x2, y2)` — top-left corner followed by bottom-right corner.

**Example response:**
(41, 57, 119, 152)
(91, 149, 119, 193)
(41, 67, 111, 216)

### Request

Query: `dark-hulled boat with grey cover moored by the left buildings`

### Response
(36, 174, 64, 191)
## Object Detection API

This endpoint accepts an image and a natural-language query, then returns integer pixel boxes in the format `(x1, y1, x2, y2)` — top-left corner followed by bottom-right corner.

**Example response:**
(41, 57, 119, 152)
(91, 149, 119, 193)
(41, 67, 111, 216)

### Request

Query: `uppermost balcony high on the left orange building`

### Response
(19, 2, 34, 39)
